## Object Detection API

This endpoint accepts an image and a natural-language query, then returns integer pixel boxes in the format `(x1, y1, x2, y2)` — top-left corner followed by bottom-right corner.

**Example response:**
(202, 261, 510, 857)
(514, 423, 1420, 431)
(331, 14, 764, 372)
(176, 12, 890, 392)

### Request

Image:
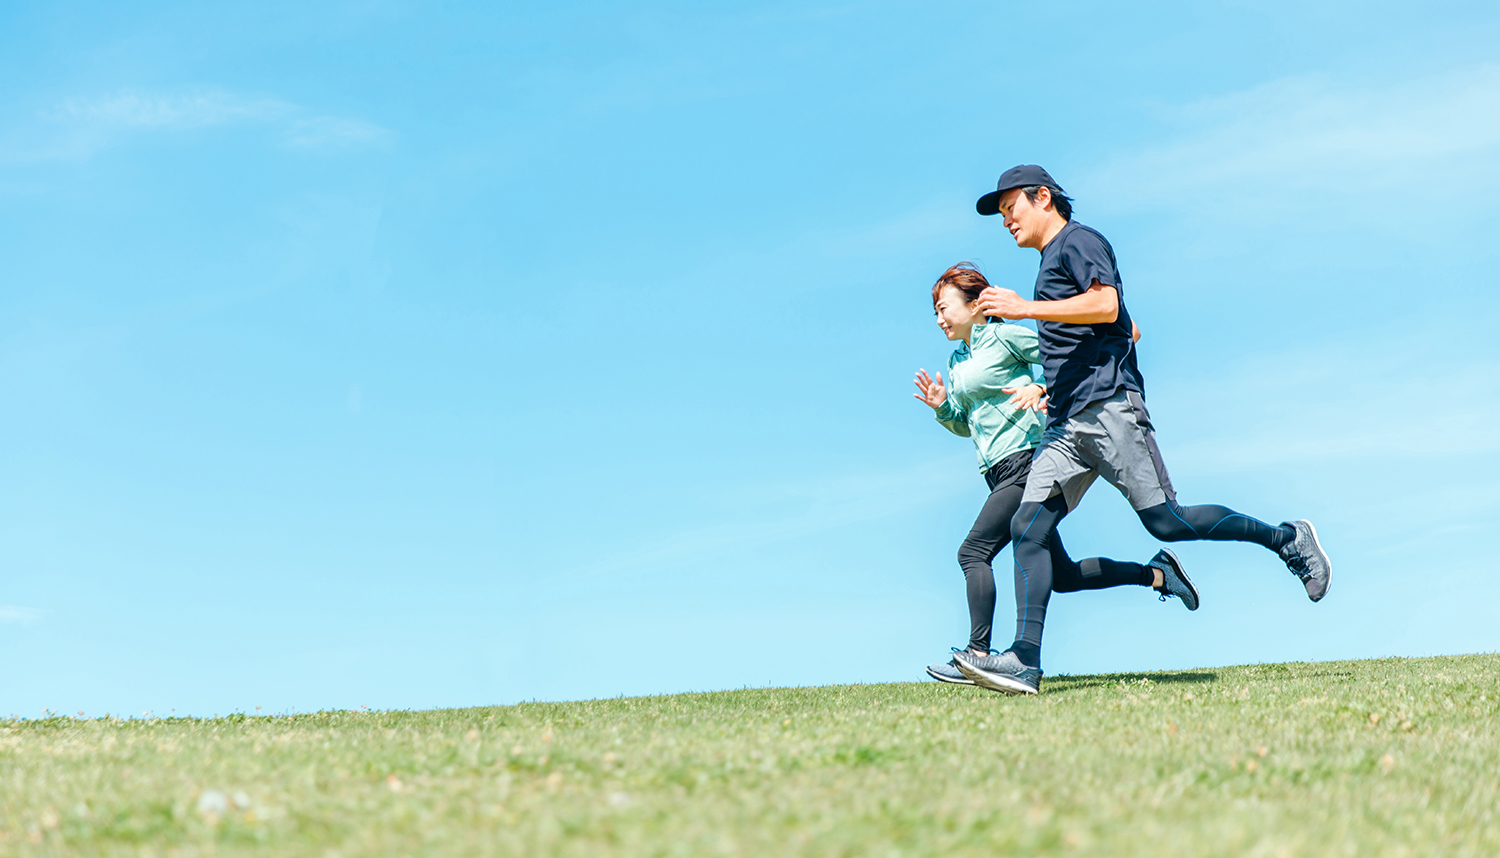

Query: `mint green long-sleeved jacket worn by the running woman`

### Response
(938, 323, 1043, 471)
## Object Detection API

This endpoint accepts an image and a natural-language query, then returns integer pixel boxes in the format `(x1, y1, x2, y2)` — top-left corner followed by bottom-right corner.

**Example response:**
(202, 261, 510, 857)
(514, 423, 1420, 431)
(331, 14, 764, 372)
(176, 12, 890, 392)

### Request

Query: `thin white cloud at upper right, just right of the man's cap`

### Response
(1080, 65, 1500, 207)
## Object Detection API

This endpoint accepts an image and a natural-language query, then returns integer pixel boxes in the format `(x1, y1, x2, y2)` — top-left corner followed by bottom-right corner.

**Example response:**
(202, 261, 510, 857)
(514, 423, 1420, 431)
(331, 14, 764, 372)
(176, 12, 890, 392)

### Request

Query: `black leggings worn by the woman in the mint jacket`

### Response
(959, 450, 1152, 653)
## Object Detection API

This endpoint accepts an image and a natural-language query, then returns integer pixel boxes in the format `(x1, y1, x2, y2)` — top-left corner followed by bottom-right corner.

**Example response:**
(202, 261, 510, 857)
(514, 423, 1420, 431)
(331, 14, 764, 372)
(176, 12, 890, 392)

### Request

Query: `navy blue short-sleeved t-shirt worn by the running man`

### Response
(1034, 221, 1146, 426)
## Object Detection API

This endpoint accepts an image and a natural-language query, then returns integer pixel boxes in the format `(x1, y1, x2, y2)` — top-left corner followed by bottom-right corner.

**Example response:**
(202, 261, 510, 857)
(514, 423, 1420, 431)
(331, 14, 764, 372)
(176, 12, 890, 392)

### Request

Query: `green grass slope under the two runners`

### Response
(0, 656, 1500, 858)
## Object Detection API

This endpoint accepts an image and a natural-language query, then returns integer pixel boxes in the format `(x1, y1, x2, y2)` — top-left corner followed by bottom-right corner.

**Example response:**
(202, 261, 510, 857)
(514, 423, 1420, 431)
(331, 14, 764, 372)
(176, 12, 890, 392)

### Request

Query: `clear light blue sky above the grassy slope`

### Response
(0, 2, 1500, 717)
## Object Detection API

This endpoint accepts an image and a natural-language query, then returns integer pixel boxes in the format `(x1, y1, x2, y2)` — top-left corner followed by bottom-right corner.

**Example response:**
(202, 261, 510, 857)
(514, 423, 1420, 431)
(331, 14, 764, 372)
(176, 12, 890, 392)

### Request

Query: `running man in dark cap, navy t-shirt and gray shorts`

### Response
(956, 165, 1332, 695)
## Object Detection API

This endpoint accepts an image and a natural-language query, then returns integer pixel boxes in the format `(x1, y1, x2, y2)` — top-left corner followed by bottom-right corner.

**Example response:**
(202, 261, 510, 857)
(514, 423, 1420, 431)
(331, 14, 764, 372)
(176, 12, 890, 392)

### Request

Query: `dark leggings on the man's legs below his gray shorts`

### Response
(1011, 494, 1290, 668)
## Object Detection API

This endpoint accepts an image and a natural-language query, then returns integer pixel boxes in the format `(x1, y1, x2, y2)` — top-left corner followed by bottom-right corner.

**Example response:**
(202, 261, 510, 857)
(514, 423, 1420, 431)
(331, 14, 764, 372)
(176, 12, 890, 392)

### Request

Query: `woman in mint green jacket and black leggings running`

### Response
(914, 263, 1199, 686)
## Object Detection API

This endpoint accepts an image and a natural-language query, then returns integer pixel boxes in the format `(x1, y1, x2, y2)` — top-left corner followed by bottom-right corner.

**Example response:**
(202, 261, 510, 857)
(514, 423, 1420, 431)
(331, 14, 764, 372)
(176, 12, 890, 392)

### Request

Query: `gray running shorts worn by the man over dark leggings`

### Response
(1022, 390, 1178, 512)
